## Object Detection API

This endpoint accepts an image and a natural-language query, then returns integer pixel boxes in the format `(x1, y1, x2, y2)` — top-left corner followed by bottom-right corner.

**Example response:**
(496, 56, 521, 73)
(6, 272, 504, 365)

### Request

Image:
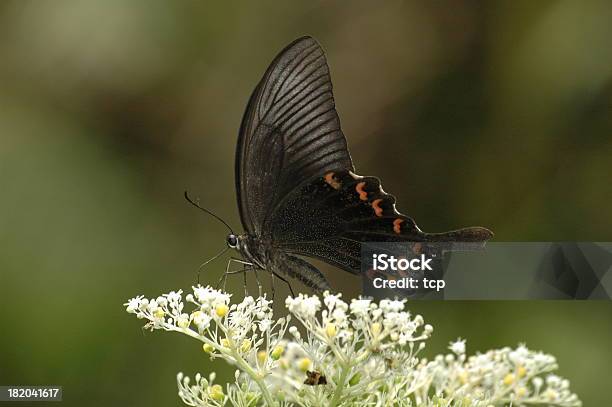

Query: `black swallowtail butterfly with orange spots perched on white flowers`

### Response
(215, 37, 492, 292)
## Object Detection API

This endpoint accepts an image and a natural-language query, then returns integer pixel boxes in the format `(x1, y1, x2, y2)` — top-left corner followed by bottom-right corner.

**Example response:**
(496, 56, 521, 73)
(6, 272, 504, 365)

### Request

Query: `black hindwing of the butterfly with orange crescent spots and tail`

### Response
(271, 170, 491, 274)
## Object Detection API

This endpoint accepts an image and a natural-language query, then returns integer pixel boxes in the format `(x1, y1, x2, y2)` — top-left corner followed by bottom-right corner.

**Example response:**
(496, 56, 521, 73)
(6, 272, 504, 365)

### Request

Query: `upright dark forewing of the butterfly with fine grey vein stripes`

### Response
(236, 37, 353, 236)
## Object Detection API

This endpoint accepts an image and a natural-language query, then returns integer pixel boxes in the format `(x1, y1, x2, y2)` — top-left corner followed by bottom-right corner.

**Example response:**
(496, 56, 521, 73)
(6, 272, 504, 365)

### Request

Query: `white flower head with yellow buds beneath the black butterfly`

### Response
(125, 286, 581, 407)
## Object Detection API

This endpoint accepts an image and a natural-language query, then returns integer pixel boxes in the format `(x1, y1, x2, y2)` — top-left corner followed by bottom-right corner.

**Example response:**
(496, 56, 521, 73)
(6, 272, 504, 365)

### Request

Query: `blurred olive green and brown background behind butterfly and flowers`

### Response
(0, 0, 612, 406)
